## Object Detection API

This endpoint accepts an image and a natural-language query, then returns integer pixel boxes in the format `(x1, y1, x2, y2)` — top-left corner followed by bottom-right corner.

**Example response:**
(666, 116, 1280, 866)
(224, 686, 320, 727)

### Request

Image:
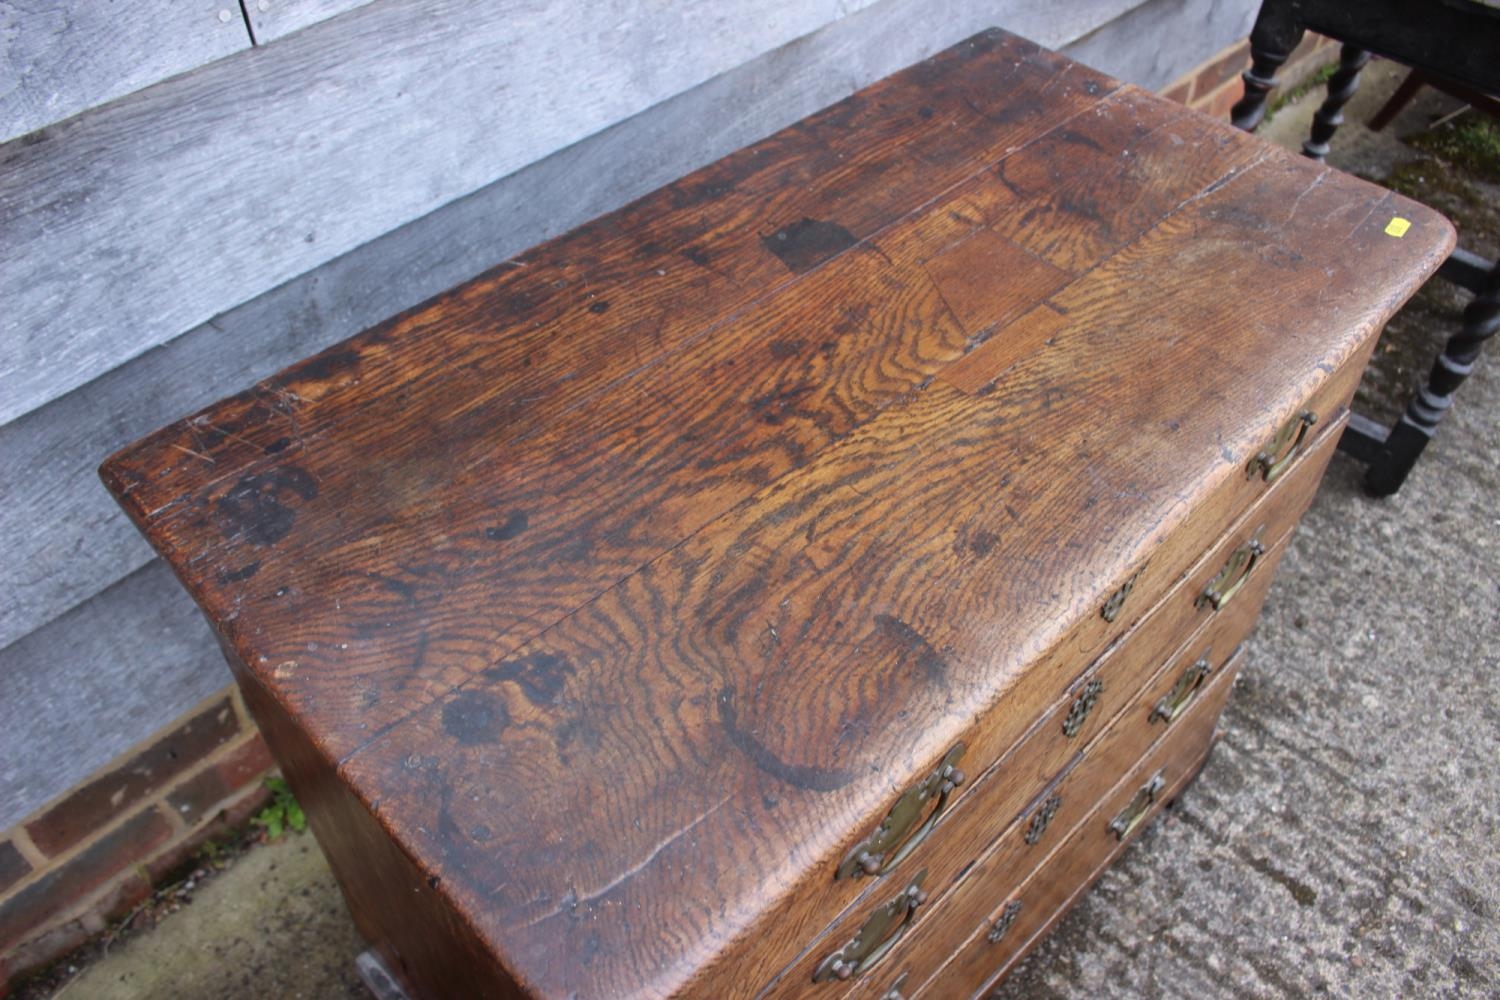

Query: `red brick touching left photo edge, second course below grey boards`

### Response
(0, 808, 173, 949)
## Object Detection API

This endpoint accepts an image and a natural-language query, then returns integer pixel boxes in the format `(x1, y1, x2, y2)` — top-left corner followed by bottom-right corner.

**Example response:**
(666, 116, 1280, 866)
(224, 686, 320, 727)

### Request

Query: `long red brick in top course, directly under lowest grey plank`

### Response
(26, 699, 240, 856)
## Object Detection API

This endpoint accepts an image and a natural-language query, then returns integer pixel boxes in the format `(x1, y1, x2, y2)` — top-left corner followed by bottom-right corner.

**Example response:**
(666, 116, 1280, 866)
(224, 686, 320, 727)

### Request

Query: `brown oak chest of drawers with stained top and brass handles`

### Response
(104, 31, 1452, 999)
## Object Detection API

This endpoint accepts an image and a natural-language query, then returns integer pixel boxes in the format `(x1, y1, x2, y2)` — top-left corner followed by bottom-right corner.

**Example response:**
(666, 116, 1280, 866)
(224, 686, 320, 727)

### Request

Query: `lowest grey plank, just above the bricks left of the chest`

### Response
(0, 562, 231, 829)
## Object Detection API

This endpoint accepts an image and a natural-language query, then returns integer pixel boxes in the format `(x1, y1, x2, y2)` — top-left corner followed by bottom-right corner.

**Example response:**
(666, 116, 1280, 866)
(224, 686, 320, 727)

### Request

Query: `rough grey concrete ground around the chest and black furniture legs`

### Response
(41, 58, 1500, 1000)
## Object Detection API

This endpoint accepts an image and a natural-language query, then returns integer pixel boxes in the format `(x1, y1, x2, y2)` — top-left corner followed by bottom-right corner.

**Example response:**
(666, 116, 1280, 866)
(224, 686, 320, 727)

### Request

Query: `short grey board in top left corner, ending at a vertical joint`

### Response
(0, 0, 251, 142)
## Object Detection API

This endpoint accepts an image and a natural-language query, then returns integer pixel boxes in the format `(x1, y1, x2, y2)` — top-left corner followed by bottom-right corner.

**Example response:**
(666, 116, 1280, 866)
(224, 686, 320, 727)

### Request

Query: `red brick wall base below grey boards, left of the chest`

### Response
(0, 688, 273, 997)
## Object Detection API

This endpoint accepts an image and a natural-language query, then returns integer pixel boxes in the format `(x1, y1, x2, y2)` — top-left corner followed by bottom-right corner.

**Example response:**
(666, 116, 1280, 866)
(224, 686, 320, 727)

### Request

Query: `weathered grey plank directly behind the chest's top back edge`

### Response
(0, 0, 1182, 648)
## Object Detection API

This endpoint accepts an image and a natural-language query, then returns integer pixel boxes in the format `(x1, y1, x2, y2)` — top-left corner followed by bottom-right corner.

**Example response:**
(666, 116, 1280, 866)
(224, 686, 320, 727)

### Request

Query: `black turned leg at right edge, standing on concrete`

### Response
(1365, 261, 1500, 496)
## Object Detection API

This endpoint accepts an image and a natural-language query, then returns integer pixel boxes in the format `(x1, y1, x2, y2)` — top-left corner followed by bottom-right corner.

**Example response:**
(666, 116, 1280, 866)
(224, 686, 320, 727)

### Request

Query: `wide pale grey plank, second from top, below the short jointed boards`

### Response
(0, 0, 872, 421)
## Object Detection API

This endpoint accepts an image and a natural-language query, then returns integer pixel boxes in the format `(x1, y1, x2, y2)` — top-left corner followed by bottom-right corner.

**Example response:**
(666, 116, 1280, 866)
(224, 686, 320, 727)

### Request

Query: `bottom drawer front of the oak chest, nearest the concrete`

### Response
(906, 657, 1239, 1000)
